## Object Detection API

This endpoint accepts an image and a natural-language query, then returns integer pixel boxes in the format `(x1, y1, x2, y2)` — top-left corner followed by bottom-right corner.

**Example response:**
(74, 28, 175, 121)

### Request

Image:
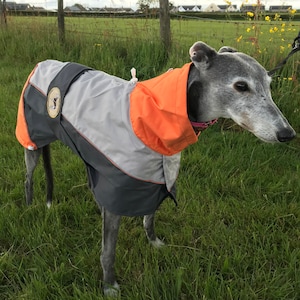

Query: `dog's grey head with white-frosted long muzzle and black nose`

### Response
(188, 42, 295, 142)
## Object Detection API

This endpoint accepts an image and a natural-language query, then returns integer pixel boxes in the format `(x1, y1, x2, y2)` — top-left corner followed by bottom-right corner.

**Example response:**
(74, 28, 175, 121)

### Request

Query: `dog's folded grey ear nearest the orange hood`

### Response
(190, 42, 217, 69)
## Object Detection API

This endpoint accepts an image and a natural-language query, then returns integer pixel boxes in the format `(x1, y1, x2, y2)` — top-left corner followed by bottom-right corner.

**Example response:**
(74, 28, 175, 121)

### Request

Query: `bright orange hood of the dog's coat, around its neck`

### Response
(130, 63, 198, 155)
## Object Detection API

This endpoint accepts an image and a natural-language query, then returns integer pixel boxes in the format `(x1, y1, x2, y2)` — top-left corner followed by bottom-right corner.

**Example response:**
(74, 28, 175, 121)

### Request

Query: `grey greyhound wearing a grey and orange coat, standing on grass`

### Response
(16, 42, 296, 296)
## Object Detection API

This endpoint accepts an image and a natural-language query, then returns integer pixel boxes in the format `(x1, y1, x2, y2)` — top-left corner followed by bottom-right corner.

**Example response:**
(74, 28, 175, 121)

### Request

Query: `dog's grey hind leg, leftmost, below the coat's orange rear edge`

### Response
(25, 149, 42, 205)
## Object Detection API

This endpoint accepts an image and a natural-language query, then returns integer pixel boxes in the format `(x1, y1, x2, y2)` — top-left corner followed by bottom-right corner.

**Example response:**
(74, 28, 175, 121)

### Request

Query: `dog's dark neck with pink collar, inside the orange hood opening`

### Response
(187, 64, 217, 134)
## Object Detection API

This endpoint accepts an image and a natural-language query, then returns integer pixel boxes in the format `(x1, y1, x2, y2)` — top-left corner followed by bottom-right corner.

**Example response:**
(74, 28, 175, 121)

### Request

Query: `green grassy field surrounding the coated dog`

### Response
(0, 17, 300, 300)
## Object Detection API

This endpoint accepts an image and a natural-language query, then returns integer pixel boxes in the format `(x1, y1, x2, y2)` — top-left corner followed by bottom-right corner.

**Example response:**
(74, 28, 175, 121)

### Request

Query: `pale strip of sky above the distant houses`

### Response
(15, 0, 300, 9)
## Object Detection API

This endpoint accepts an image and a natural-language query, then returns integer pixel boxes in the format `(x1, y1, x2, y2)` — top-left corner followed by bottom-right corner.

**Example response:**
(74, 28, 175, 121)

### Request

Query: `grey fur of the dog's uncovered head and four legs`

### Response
(25, 42, 295, 296)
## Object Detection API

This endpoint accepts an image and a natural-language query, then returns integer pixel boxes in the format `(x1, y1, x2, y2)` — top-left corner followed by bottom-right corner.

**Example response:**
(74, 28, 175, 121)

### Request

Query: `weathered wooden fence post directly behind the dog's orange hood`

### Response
(159, 0, 171, 52)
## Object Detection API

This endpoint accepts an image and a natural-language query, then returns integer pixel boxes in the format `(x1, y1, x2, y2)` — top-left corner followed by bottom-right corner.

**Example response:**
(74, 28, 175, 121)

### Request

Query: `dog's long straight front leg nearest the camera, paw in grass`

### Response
(101, 207, 121, 297)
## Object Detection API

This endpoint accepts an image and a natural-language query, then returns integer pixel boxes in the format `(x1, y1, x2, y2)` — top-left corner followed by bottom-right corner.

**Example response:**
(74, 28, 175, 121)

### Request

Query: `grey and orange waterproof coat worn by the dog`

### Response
(16, 60, 197, 216)
